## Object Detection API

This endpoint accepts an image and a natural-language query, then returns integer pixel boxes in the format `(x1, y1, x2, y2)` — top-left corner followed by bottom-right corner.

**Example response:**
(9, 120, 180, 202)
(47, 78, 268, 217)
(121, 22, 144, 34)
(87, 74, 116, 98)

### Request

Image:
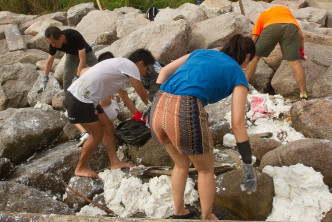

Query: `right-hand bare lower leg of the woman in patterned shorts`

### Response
(189, 151, 218, 220)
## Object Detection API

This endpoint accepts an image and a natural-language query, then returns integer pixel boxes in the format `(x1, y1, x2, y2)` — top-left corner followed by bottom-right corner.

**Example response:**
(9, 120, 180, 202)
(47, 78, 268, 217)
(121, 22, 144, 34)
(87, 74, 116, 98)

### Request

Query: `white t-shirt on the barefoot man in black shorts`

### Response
(68, 58, 140, 106)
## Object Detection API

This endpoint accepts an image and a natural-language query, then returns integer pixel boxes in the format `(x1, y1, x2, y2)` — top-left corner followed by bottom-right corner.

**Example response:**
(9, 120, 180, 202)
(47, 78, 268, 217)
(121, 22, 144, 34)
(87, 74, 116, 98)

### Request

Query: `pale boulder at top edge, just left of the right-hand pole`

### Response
(199, 0, 232, 18)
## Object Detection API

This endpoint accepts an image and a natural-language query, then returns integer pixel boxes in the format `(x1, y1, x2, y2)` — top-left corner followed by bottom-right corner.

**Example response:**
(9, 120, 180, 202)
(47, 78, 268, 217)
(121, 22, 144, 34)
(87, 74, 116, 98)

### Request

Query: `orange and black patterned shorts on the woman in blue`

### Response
(150, 90, 213, 155)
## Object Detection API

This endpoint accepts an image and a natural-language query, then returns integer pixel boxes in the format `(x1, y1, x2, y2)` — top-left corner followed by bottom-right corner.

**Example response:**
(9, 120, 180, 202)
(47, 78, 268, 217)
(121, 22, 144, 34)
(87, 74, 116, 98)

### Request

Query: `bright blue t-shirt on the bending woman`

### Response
(161, 49, 249, 106)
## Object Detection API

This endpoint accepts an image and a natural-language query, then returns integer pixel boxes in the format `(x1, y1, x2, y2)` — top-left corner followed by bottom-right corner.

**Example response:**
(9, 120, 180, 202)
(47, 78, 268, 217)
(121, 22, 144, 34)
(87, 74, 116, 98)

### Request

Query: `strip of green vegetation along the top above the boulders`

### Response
(0, 0, 204, 15)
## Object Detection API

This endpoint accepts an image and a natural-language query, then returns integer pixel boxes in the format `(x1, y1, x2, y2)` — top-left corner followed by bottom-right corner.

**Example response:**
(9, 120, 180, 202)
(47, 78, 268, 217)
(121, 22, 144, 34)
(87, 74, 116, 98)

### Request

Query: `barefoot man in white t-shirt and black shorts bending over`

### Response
(65, 49, 155, 178)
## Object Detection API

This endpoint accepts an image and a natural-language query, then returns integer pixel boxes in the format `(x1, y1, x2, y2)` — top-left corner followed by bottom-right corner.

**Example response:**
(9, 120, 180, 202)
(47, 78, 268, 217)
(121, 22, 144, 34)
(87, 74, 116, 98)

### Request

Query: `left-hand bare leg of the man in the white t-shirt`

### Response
(75, 121, 103, 178)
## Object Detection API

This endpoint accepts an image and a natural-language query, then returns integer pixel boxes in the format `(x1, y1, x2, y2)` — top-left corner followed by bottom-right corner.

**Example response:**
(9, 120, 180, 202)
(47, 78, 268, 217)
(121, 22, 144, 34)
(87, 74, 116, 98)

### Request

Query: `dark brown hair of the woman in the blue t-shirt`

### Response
(220, 34, 256, 65)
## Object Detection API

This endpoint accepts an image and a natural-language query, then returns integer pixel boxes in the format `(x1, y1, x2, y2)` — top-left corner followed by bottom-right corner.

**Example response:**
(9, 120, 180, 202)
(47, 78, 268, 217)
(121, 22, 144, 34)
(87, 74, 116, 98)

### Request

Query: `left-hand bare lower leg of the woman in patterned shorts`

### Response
(165, 143, 190, 215)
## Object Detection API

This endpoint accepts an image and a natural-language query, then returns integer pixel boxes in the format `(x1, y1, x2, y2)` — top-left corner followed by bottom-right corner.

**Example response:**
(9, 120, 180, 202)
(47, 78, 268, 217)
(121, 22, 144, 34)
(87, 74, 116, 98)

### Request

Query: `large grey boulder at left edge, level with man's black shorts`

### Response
(0, 108, 68, 164)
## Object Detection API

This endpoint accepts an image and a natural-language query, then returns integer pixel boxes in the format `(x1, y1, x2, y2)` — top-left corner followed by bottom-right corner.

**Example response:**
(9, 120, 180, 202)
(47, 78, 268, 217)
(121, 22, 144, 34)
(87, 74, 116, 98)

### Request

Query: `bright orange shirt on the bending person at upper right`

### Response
(251, 5, 301, 35)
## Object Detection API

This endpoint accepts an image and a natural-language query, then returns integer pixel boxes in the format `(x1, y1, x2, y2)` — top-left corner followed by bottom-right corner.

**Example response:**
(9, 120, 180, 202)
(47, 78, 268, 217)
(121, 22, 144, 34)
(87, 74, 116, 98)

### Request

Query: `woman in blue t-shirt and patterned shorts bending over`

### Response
(150, 35, 256, 220)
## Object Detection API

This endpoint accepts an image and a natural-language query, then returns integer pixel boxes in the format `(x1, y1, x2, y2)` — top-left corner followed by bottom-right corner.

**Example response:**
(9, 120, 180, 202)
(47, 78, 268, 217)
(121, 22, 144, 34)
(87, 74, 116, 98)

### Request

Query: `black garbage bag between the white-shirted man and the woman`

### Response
(115, 118, 151, 146)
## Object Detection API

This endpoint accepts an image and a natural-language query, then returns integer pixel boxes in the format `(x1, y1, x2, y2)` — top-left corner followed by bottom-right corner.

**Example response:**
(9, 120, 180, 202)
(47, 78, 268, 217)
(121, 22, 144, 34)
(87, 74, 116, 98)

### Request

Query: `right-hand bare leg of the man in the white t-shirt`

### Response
(98, 113, 134, 170)
